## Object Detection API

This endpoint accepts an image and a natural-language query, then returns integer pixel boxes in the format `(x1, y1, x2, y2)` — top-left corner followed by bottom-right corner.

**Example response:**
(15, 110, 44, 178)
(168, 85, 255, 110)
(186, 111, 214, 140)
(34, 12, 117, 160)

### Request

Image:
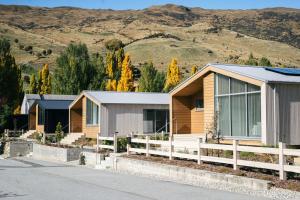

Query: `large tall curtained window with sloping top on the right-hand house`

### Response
(215, 74, 261, 137)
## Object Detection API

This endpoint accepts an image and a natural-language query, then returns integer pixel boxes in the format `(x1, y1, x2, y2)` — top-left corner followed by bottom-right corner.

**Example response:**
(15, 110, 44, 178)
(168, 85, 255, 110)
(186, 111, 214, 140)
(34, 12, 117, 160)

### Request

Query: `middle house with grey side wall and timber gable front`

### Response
(69, 91, 169, 138)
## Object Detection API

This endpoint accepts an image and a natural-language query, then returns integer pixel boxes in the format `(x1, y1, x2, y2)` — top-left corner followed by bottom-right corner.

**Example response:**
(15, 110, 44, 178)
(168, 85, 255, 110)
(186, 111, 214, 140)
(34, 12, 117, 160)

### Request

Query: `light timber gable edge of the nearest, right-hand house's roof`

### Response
(169, 63, 267, 96)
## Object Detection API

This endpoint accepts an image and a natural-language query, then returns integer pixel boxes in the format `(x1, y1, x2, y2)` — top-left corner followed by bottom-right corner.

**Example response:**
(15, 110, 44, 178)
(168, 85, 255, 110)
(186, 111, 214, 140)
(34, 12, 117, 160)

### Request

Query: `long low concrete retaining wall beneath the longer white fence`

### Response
(115, 157, 270, 190)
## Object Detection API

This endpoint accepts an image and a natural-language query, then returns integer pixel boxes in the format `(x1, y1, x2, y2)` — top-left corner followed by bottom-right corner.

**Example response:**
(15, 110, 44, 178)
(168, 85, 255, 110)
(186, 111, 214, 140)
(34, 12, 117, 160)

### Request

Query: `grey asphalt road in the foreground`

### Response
(0, 158, 265, 200)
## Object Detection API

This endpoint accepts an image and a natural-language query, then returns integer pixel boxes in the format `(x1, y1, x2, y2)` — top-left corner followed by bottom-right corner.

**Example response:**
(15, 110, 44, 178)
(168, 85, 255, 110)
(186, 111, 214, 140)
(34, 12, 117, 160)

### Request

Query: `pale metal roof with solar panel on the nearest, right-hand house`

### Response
(207, 64, 300, 83)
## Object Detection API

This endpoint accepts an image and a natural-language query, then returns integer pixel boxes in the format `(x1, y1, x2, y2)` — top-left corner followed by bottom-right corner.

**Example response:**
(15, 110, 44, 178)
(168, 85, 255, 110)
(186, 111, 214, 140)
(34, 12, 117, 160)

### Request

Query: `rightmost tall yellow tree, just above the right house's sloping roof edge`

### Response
(164, 58, 181, 92)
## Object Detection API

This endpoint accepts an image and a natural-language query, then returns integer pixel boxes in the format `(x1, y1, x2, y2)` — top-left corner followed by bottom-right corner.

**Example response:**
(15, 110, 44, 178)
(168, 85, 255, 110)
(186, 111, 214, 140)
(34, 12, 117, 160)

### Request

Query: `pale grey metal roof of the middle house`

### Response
(83, 91, 169, 104)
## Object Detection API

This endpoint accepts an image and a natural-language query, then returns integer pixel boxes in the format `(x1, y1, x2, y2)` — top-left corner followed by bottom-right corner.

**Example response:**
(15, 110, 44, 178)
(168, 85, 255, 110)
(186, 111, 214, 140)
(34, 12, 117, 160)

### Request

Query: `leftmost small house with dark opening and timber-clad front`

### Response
(28, 95, 76, 133)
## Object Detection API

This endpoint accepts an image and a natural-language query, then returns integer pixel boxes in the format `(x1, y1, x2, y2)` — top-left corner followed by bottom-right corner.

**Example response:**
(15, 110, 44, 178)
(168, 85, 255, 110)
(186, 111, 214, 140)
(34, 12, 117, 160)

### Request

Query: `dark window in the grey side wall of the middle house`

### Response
(143, 109, 169, 133)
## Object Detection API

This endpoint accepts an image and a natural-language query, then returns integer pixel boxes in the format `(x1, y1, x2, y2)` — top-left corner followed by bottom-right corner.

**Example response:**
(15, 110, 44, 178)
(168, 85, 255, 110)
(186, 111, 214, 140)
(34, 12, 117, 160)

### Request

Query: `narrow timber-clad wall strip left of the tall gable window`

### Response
(203, 72, 215, 133)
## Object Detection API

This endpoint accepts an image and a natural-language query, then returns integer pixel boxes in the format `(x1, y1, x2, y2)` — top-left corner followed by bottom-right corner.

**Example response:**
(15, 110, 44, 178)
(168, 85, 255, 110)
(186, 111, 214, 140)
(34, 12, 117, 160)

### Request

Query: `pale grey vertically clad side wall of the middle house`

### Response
(100, 104, 169, 136)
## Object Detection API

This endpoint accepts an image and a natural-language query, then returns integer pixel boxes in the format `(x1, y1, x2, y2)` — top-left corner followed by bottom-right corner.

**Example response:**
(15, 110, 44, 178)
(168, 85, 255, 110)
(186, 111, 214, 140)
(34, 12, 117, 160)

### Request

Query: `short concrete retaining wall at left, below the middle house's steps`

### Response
(32, 143, 82, 162)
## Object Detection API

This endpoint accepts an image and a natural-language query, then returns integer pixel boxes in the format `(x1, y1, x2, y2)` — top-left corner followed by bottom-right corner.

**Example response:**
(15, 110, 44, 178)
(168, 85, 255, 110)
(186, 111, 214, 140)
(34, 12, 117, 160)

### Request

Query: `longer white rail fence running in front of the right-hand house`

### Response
(127, 136, 300, 180)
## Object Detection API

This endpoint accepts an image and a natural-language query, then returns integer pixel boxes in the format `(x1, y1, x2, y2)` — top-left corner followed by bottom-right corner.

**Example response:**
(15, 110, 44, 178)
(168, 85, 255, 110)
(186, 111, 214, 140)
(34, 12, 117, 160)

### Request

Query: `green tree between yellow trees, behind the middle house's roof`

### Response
(138, 63, 165, 92)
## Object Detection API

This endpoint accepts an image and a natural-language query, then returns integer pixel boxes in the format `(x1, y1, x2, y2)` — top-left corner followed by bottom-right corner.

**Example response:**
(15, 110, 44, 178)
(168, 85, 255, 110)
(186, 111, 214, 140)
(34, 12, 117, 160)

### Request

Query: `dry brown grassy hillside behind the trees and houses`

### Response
(0, 4, 300, 73)
